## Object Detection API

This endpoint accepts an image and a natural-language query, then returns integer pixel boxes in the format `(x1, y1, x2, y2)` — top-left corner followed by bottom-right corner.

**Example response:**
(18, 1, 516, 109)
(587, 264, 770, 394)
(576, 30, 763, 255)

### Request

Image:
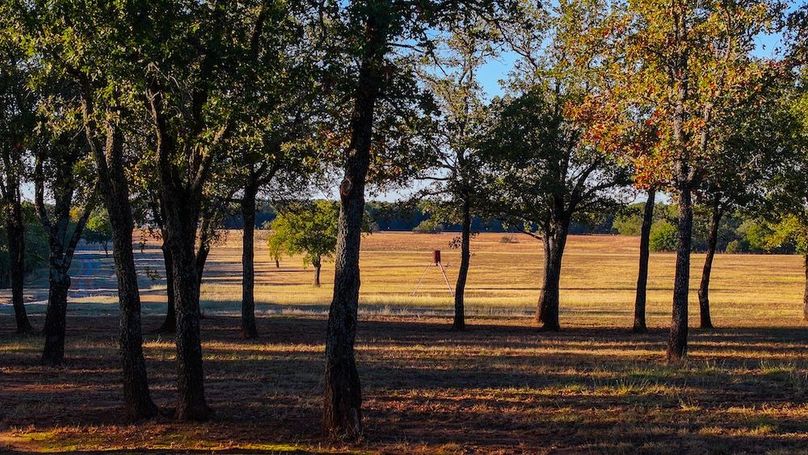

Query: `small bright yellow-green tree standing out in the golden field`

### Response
(268, 201, 339, 287)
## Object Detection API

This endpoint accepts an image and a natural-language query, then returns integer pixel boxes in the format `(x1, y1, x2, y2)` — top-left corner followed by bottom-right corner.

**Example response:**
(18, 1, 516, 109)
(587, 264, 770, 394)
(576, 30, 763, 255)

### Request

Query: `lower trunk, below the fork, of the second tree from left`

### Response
(41, 268, 70, 366)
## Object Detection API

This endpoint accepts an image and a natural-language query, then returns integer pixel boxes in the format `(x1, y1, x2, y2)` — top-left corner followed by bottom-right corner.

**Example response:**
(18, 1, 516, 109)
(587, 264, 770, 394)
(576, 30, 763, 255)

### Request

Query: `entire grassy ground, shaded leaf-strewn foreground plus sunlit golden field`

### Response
(0, 233, 808, 453)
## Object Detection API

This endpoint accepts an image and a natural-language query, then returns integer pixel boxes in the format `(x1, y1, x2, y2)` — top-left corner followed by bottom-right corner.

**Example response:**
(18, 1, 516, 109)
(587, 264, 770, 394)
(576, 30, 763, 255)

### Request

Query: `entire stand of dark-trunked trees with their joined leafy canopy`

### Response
(0, 0, 808, 440)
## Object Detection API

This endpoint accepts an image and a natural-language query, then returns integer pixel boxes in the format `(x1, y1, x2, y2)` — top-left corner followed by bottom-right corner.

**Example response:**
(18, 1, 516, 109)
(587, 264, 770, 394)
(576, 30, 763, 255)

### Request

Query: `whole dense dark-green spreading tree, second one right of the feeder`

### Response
(485, 2, 629, 331)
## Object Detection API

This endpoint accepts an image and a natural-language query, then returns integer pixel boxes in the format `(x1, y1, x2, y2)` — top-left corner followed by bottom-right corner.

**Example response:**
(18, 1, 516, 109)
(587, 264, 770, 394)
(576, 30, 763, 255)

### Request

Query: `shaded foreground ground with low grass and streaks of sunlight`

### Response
(0, 314, 808, 453)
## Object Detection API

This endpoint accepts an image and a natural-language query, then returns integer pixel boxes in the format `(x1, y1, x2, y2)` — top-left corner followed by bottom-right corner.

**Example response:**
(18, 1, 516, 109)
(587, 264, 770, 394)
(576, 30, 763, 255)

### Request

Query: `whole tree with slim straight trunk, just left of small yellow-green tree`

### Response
(226, 17, 322, 338)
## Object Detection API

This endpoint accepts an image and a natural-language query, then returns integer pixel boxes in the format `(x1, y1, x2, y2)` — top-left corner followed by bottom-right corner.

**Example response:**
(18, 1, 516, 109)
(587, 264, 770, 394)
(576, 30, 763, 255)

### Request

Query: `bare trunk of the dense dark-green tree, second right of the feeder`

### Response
(536, 220, 569, 332)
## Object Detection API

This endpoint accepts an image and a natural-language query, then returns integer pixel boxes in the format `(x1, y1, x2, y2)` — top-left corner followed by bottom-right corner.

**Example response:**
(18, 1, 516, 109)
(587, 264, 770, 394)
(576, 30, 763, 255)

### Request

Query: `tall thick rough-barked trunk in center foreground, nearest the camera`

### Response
(323, 5, 392, 441)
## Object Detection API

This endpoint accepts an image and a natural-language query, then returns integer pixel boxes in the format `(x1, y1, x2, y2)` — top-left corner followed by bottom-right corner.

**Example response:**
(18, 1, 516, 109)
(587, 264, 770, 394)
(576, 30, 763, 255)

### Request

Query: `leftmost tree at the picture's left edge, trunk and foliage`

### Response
(0, 29, 36, 333)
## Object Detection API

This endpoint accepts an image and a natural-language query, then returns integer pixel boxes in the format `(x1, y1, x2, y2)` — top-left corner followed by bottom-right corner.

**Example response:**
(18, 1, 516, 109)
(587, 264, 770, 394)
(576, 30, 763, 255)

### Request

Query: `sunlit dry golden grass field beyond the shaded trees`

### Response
(194, 232, 804, 327)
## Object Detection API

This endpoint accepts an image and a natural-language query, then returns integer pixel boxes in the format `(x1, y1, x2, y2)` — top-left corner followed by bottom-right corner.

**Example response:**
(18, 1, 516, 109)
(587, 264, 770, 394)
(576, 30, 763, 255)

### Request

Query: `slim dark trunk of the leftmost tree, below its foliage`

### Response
(6, 205, 34, 333)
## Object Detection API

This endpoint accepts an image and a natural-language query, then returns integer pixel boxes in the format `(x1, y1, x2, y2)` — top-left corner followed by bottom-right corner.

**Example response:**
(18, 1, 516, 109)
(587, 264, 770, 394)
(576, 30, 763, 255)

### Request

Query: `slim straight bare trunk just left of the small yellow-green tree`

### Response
(241, 185, 258, 338)
